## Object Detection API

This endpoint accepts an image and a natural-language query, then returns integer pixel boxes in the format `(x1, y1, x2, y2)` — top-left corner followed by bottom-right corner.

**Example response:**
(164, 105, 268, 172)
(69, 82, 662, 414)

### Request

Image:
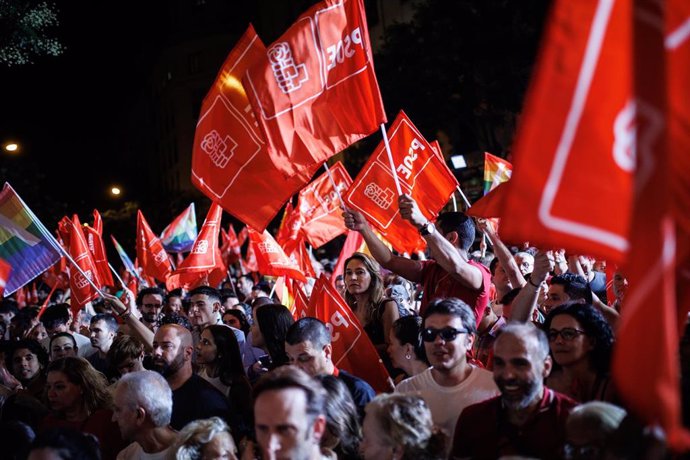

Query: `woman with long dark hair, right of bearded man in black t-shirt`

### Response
(196, 324, 254, 442)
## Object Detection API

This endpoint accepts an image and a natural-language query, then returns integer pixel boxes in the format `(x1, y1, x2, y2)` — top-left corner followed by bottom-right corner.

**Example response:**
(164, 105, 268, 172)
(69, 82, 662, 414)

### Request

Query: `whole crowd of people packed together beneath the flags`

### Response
(0, 195, 688, 460)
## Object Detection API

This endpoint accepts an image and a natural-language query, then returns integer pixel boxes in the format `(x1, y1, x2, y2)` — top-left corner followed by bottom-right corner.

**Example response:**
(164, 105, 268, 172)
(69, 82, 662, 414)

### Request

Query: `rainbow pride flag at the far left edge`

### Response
(0, 182, 61, 297)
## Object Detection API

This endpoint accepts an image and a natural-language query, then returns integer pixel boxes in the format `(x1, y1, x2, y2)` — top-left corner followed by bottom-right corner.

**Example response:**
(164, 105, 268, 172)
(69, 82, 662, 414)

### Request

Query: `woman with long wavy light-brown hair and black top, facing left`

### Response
(345, 252, 400, 356)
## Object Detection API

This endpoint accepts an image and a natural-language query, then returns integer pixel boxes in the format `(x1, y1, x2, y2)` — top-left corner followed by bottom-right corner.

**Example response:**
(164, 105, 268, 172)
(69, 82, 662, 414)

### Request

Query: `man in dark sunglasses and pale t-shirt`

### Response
(396, 298, 499, 448)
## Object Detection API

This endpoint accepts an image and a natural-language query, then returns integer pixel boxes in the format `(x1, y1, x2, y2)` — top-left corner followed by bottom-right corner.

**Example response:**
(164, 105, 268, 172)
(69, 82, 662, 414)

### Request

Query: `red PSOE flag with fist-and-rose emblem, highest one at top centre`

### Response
(242, 0, 386, 177)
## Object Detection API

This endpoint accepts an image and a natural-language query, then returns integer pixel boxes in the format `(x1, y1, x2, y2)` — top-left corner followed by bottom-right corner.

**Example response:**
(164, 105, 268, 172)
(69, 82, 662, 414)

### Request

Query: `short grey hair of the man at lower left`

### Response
(117, 371, 172, 427)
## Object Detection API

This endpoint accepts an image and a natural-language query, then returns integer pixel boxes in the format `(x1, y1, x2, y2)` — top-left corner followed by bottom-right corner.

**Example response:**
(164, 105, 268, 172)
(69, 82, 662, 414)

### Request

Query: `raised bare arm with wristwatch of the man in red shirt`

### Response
(398, 194, 483, 289)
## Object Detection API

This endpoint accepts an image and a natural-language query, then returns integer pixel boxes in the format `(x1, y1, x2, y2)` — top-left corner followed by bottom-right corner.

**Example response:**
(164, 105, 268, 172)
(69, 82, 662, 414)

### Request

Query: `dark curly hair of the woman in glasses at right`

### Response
(543, 302, 614, 376)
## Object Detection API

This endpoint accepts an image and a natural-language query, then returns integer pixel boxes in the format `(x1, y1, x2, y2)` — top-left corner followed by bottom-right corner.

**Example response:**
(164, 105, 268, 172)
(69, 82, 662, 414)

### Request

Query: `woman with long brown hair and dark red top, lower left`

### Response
(38, 357, 126, 459)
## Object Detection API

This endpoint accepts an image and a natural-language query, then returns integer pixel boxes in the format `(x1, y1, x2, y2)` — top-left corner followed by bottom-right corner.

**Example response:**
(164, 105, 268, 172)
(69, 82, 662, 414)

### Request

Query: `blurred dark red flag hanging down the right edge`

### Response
(613, 0, 690, 452)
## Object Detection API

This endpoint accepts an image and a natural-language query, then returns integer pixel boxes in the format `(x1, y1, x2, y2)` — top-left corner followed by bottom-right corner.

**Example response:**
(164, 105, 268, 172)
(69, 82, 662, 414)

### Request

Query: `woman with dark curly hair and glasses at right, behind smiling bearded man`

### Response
(544, 302, 614, 402)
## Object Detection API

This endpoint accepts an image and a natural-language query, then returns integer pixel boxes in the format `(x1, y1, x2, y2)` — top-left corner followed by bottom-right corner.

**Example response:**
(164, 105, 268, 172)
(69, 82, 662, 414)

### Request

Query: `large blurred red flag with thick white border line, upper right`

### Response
(501, 0, 634, 262)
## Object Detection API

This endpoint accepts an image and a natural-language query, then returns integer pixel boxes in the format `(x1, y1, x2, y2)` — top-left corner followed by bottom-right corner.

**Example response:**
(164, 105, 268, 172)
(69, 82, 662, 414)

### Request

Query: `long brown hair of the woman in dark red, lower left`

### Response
(47, 356, 112, 414)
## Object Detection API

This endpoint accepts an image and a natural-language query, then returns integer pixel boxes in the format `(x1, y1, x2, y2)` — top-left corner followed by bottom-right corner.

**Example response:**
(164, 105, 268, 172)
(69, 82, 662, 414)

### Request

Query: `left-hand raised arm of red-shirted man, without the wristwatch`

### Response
(343, 209, 422, 283)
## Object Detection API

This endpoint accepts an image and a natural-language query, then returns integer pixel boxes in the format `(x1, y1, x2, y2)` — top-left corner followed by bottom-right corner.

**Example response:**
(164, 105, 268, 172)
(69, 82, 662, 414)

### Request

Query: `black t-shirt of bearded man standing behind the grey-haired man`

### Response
(170, 374, 230, 431)
